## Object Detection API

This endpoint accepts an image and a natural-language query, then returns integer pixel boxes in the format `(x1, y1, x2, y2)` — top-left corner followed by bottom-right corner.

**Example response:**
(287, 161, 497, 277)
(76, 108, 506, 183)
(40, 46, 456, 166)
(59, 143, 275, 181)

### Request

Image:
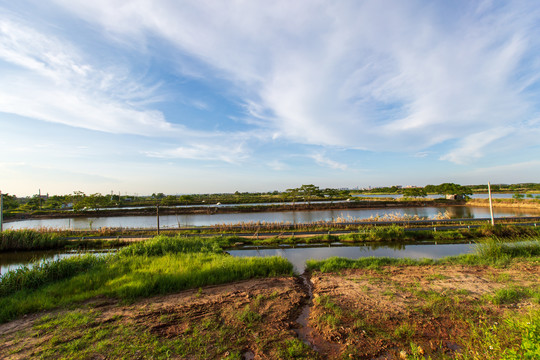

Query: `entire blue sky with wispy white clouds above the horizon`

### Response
(0, 0, 540, 196)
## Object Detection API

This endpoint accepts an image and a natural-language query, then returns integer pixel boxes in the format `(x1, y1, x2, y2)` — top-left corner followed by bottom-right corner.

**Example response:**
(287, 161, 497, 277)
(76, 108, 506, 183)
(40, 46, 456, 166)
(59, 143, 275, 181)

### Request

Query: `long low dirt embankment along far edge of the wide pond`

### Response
(5, 200, 464, 220)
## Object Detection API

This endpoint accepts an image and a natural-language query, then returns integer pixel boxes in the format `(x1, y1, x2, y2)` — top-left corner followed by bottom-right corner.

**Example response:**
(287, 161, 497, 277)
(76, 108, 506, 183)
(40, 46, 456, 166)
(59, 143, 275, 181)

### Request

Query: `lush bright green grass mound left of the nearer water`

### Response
(0, 237, 293, 322)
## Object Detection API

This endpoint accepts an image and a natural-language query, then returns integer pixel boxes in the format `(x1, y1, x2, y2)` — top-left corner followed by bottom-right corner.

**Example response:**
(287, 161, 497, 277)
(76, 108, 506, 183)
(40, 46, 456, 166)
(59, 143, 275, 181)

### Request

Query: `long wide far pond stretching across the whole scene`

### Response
(4, 206, 540, 230)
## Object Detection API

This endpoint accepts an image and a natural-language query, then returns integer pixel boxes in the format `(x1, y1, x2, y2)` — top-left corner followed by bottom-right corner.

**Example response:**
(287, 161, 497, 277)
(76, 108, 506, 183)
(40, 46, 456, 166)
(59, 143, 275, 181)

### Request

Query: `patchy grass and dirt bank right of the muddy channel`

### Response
(308, 238, 540, 360)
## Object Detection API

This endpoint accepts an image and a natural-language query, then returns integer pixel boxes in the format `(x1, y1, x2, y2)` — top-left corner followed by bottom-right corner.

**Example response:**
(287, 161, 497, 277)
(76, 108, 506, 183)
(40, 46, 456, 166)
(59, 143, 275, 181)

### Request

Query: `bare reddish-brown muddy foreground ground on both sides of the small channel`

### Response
(0, 263, 540, 359)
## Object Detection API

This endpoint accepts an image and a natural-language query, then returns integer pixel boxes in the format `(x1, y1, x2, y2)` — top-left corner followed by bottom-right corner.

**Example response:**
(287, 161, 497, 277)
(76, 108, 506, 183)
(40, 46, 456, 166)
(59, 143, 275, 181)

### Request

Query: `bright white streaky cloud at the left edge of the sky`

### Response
(0, 19, 174, 135)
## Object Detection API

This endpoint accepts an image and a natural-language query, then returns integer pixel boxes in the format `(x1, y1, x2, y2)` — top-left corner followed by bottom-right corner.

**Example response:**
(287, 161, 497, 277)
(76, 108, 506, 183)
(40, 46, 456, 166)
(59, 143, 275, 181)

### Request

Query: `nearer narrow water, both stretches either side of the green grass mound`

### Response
(0, 243, 475, 280)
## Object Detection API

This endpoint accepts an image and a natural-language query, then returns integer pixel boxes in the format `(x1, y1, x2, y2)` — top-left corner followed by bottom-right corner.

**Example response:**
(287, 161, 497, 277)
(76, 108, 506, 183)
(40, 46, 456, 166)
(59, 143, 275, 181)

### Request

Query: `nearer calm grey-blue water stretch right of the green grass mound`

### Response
(228, 244, 475, 274)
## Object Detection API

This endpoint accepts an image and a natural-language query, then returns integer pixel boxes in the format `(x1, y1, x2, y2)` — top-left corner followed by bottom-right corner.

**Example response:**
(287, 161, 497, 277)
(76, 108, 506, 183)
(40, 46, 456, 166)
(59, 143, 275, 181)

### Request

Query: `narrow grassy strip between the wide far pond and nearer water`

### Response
(4, 225, 540, 252)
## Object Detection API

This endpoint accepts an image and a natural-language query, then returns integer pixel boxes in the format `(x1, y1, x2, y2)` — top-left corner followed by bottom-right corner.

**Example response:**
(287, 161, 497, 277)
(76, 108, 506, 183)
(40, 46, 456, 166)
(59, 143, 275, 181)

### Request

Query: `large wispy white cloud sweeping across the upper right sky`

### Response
(49, 0, 540, 162)
